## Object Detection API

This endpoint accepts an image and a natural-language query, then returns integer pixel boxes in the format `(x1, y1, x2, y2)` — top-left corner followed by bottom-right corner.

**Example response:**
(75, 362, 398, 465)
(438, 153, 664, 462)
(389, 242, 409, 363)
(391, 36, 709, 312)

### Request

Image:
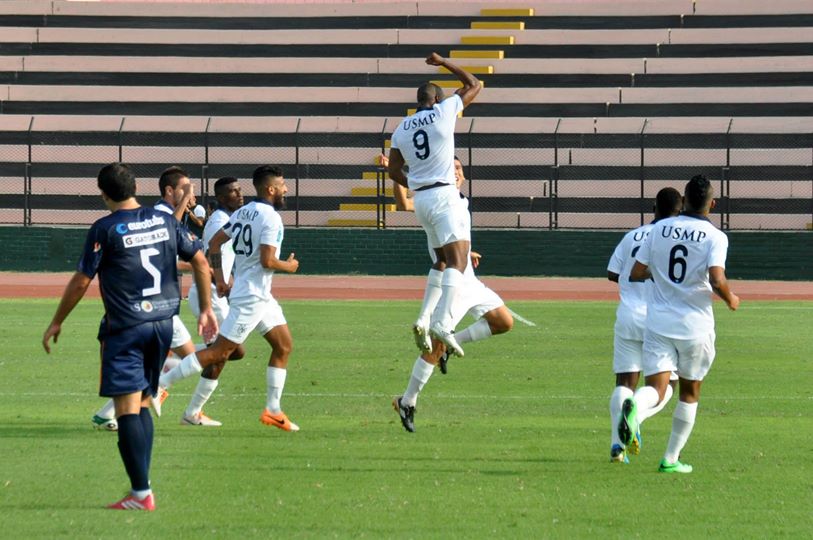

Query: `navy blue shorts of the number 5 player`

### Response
(99, 319, 172, 397)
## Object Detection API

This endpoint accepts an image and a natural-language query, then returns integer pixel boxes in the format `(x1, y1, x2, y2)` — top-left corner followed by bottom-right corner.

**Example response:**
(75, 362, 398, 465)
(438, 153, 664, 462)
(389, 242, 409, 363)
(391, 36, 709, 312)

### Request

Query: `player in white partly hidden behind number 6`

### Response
(607, 188, 683, 463)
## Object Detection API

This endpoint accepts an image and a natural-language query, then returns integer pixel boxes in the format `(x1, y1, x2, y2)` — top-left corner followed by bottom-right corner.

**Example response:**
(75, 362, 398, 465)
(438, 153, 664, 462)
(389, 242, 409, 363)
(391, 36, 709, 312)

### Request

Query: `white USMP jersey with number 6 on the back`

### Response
(635, 214, 728, 339)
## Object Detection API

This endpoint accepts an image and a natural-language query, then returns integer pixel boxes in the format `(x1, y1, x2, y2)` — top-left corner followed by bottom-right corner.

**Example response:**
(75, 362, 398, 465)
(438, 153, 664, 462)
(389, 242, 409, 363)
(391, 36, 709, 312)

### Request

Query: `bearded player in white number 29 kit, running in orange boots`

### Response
(162, 165, 299, 431)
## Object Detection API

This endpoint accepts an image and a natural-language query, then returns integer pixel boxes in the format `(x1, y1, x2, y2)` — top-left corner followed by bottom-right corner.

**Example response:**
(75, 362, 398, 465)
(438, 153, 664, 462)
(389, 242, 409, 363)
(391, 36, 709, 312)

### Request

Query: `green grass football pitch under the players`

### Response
(0, 300, 813, 538)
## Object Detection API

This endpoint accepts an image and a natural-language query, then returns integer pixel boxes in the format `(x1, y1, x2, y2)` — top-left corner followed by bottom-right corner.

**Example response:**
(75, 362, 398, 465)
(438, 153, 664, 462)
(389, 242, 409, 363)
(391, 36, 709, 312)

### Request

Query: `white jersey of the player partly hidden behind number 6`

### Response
(607, 223, 652, 341)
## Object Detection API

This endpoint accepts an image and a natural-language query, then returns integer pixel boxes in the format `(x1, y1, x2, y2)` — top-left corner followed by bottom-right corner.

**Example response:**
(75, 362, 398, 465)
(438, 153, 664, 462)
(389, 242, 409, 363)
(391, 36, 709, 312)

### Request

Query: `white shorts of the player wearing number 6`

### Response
(644, 330, 716, 381)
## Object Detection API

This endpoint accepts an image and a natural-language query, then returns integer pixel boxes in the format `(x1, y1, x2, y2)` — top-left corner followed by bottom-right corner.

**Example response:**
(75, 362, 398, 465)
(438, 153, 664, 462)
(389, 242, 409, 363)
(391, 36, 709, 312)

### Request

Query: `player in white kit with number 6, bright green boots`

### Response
(618, 175, 740, 473)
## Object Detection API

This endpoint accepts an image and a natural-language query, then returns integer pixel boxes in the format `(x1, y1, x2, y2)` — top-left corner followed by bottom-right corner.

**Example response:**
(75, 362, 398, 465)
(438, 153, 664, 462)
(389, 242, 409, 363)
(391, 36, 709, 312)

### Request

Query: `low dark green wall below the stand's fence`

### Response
(0, 227, 813, 281)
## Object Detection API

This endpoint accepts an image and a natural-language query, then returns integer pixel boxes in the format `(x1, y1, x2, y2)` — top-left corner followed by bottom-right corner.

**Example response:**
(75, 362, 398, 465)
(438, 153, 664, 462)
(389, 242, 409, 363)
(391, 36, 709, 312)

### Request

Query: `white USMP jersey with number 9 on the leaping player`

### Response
(391, 94, 463, 191)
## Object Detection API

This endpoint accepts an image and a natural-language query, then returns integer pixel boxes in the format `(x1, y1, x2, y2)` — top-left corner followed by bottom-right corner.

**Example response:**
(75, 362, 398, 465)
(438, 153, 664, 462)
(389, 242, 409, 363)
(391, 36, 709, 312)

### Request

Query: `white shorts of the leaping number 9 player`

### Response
(414, 186, 471, 248)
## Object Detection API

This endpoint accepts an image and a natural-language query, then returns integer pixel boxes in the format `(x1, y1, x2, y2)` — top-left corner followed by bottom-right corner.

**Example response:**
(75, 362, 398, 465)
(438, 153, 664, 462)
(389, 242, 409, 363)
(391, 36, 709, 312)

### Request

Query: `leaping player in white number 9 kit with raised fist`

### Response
(388, 53, 481, 356)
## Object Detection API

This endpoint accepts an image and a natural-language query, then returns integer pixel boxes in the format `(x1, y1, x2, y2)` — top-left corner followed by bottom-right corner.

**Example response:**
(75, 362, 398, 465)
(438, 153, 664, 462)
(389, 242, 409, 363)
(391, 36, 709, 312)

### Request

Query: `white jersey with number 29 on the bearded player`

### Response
(223, 201, 284, 300)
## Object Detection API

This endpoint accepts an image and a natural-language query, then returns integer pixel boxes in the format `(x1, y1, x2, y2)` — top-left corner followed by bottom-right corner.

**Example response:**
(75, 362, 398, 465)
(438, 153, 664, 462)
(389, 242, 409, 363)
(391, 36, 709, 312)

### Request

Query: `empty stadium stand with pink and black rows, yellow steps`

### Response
(0, 0, 813, 230)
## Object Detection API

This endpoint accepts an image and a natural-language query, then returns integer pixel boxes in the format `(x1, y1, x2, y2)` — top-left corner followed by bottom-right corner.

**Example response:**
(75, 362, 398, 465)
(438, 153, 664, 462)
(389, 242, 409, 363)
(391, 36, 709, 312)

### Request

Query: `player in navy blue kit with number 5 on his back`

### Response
(42, 163, 217, 510)
